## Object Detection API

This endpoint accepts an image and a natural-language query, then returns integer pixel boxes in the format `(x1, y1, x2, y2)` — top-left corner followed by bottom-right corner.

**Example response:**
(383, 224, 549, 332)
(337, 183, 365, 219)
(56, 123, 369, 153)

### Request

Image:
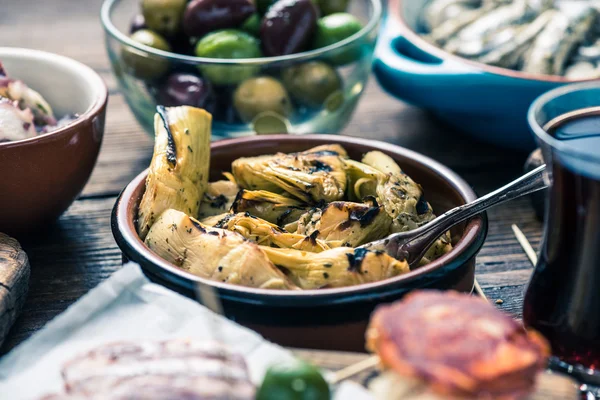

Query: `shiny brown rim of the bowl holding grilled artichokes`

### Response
(112, 135, 487, 303)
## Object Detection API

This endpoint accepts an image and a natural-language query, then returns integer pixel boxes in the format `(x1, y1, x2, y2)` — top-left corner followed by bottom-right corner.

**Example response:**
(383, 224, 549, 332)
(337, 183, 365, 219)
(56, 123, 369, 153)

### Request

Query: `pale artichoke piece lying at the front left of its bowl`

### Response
(145, 209, 297, 289)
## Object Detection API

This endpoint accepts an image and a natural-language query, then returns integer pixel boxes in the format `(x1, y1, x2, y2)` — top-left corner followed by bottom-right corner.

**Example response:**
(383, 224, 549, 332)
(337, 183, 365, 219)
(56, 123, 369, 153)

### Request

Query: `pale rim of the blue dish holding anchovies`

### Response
(389, 0, 597, 83)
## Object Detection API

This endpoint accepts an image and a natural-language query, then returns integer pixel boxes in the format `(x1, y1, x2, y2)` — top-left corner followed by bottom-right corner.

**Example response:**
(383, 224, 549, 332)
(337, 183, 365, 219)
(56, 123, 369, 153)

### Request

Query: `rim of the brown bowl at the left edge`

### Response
(0, 47, 108, 149)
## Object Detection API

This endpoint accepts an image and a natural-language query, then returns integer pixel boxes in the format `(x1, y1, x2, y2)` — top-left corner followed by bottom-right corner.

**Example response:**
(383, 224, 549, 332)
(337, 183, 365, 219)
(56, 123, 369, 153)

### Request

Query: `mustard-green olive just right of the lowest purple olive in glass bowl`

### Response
(233, 76, 292, 122)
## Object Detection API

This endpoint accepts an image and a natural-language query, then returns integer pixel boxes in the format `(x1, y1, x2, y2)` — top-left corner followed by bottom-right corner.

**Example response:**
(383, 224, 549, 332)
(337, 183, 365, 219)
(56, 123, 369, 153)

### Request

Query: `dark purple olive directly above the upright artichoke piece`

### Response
(156, 73, 214, 113)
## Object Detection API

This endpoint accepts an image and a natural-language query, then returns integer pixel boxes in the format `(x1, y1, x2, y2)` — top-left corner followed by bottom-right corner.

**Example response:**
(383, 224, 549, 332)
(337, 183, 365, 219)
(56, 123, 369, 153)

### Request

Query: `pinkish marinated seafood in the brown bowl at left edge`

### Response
(0, 62, 76, 142)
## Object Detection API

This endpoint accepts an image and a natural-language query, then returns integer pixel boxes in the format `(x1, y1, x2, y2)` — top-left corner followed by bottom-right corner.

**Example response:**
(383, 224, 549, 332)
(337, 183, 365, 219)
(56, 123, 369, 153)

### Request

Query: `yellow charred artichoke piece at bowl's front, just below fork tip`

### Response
(262, 247, 410, 289)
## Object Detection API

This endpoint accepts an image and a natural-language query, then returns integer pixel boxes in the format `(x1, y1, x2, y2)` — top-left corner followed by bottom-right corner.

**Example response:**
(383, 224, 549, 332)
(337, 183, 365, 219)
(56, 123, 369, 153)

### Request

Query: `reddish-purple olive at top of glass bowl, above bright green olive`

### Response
(183, 0, 256, 37)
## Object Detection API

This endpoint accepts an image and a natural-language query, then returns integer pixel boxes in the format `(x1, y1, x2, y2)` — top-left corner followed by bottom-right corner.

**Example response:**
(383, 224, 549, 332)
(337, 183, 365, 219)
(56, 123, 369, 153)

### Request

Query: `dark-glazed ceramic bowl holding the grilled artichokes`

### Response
(112, 135, 487, 351)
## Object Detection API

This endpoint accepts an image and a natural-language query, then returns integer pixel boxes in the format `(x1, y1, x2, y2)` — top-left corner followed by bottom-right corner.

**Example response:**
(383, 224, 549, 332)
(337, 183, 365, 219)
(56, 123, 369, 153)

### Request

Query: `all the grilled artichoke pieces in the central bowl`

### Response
(137, 106, 452, 290)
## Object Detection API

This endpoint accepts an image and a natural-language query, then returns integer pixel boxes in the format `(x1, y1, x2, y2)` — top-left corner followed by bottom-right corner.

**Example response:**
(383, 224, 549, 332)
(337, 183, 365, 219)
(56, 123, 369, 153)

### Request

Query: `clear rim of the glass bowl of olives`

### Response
(100, 0, 382, 65)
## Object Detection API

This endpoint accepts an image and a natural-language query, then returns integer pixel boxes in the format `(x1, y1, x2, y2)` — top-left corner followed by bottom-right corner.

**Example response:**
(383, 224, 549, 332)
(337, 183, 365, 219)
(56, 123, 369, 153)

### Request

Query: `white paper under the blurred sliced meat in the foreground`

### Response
(0, 263, 370, 400)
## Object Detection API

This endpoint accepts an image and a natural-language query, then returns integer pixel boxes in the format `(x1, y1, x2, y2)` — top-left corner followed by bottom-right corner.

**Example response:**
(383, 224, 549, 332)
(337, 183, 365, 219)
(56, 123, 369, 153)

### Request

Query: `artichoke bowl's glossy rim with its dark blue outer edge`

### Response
(111, 135, 488, 307)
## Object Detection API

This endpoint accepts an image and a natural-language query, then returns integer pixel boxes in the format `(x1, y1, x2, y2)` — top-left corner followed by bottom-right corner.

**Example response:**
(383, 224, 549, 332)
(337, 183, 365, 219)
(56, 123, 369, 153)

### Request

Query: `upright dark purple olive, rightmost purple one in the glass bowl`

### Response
(260, 0, 318, 56)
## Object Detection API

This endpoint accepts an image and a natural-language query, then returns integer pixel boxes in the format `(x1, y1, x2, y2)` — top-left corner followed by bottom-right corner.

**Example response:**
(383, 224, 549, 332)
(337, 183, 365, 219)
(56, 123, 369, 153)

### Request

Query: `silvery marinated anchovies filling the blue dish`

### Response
(420, 0, 600, 80)
